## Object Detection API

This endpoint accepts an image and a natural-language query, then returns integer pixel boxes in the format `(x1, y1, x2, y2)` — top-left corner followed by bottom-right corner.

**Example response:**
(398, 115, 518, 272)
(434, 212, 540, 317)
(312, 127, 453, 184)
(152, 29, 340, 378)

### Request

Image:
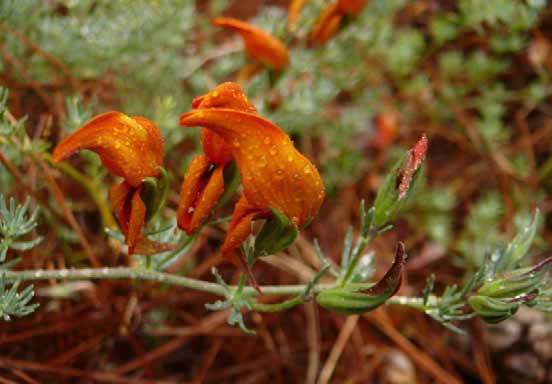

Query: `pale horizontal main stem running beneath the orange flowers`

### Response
(2, 267, 424, 309)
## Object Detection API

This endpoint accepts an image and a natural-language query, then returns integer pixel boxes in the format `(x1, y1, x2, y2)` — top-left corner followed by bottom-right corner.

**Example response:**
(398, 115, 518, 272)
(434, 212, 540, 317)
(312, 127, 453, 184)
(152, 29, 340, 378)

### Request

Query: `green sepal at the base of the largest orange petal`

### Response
(255, 207, 299, 256)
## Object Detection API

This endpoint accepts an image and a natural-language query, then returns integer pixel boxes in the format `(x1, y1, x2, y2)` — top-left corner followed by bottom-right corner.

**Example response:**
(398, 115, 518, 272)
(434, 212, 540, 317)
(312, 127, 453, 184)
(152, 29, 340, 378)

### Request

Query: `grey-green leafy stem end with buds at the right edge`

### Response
(422, 211, 552, 331)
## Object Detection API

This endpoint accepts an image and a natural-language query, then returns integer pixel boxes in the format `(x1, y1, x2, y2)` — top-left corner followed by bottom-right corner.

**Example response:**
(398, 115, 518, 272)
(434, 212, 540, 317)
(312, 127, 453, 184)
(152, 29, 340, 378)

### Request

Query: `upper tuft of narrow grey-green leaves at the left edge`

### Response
(0, 194, 42, 262)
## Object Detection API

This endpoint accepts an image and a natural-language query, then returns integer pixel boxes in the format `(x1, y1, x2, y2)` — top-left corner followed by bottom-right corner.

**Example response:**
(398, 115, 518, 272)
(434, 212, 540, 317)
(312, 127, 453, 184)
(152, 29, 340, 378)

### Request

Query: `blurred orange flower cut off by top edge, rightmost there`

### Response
(309, 0, 366, 45)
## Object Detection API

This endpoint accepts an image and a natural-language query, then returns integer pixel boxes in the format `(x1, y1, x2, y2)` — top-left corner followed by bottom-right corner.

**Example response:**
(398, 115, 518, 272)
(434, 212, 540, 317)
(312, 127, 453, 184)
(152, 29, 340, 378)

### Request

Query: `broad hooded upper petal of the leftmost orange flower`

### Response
(53, 111, 163, 187)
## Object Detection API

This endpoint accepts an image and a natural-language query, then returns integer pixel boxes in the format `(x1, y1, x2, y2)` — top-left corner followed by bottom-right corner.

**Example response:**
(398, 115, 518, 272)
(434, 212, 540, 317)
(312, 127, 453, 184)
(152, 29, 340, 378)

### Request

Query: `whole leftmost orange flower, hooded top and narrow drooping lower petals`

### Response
(53, 111, 163, 254)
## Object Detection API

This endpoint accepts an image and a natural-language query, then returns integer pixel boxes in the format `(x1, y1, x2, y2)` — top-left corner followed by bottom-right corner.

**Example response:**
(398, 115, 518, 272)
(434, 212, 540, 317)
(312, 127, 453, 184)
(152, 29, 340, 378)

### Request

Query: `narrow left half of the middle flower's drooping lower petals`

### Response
(177, 155, 211, 235)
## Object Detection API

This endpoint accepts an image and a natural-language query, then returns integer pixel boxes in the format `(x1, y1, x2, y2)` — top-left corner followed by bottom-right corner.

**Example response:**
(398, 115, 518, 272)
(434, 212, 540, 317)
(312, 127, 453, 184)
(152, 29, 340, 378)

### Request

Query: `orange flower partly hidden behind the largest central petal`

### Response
(177, 82, 255, 235)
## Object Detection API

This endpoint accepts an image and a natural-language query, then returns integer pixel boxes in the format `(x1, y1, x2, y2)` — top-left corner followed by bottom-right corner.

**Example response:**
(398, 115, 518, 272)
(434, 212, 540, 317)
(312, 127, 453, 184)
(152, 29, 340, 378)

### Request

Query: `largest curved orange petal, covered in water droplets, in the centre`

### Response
(180, 109, 324, 225)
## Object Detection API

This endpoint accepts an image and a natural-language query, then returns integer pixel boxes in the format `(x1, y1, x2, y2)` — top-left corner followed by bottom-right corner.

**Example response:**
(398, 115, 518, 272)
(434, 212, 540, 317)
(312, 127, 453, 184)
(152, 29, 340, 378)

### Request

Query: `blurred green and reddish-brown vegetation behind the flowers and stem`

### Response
(0, 0, 552, 383)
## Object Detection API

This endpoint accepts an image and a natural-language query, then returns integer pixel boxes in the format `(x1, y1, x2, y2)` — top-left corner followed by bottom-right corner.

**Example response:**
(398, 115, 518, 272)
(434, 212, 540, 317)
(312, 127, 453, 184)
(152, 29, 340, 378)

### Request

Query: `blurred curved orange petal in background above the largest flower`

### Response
(213, 17, 289, 71)
